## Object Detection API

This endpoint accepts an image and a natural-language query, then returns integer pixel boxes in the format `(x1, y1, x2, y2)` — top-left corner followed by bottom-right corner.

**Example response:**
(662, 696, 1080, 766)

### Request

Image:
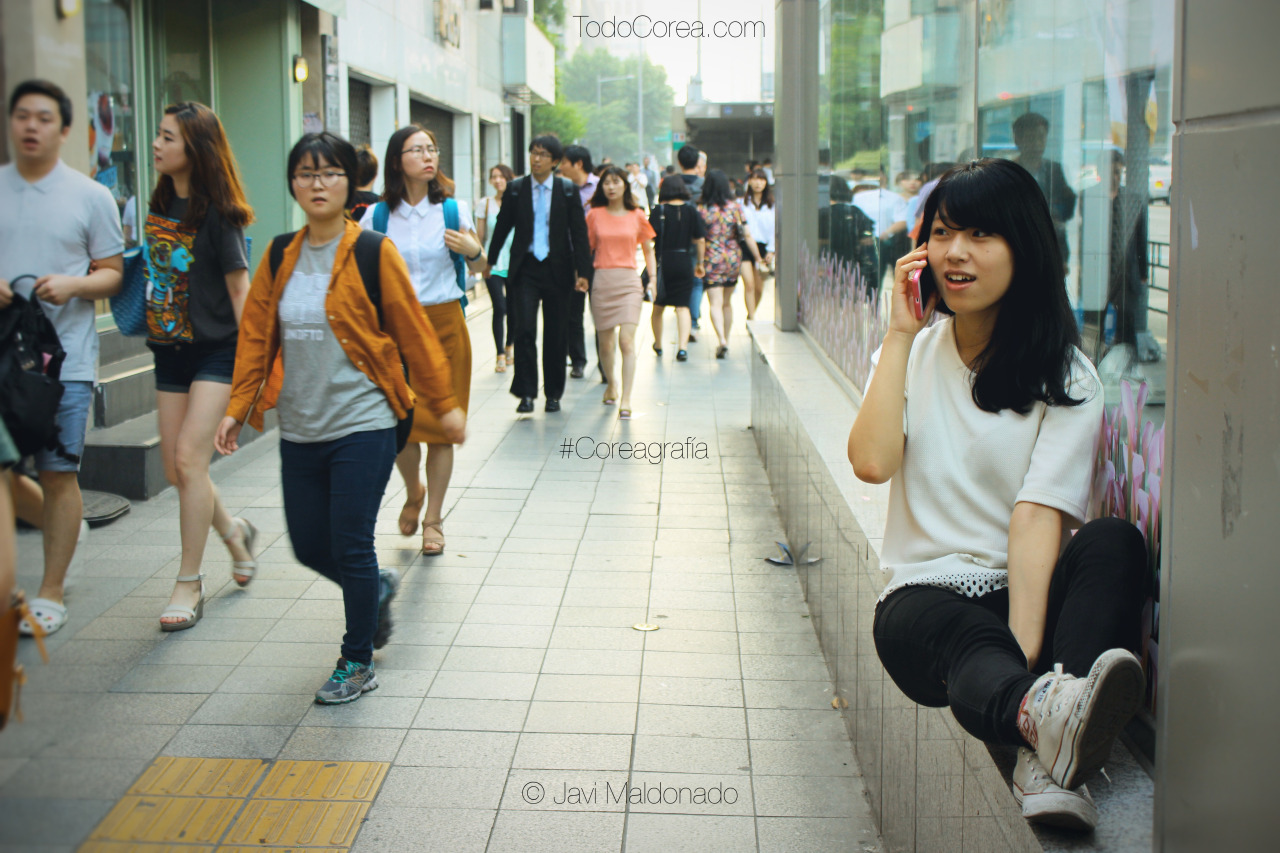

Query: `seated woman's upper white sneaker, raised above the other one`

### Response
(1018, 648, 1146, 789)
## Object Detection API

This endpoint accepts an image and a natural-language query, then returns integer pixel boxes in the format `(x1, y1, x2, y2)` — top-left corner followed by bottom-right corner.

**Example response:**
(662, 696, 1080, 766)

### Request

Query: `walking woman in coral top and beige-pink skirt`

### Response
(586, 165, 658, 420)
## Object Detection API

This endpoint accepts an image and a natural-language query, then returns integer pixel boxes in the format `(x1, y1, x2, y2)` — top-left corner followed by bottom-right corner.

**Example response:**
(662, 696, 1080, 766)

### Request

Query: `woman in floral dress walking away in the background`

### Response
(698, 169, 760, 359)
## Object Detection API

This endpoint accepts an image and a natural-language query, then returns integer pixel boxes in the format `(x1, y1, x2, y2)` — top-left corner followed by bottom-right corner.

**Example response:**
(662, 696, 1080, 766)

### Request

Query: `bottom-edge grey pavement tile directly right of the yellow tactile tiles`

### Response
(351, 800, 495, 853)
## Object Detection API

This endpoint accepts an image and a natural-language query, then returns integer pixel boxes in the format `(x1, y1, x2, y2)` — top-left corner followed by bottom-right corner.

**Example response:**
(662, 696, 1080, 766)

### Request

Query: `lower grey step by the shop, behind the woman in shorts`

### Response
(79, 411, 276, 501)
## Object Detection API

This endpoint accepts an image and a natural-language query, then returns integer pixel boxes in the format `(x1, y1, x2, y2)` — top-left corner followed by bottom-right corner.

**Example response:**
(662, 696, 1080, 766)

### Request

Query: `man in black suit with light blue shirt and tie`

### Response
(489, 136, 591, 412)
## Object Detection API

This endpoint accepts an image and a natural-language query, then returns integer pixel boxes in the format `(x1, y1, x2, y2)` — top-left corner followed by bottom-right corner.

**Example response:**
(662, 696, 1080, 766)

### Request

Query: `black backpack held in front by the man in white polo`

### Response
(0, 275, 79, 462)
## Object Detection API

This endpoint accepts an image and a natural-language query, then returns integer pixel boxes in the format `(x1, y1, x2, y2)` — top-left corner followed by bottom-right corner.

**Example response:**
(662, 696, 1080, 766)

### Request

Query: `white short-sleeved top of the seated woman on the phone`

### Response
(867, 318, 1103, 599)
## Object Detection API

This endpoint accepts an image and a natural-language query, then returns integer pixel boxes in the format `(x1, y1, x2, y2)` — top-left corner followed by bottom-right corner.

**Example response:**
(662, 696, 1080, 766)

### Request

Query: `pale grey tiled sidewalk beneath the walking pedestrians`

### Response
(0, 286, 881, 853)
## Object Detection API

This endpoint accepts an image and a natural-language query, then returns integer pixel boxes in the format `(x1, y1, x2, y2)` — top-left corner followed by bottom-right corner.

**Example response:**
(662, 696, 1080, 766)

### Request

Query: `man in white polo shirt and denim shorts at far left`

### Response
(0, 79, 124, 633)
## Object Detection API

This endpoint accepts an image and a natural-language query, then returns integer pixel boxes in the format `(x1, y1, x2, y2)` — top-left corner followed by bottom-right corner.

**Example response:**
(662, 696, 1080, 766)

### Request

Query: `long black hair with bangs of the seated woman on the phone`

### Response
(915, 158, 1084, 415)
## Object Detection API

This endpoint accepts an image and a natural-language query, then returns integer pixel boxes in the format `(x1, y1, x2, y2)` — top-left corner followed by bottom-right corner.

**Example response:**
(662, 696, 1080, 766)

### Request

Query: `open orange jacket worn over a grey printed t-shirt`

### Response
(227, 220, 458, 430)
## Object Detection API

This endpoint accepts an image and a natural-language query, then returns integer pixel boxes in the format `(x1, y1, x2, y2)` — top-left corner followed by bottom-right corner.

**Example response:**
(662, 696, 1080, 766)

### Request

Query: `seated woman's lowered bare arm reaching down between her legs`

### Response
(1009, 501, 1062, 667)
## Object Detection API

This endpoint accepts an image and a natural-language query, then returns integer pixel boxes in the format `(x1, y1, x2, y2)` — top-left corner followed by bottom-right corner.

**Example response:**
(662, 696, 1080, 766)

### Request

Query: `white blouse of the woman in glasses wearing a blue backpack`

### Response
(360, 199, 476, 305)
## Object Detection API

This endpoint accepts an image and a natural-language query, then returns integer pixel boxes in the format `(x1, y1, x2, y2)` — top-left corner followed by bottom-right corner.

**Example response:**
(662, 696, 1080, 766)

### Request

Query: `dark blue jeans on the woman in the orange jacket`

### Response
(280, 428, 396, 663)
